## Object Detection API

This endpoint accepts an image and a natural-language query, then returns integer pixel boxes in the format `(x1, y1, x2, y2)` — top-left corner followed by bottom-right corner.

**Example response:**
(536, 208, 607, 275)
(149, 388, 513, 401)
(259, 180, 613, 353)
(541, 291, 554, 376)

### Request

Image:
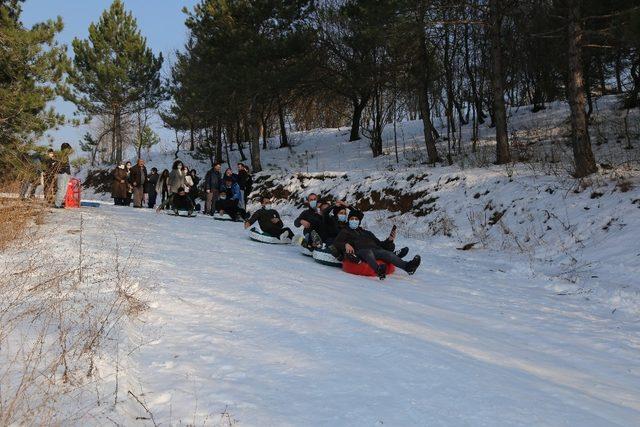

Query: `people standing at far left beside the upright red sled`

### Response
(20, 142, 73, 208)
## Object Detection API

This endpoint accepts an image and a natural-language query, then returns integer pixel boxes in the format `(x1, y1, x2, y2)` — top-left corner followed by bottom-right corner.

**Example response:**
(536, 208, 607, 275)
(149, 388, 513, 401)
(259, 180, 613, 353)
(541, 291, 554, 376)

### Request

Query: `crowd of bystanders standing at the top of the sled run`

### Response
(111, 159, 253, 219)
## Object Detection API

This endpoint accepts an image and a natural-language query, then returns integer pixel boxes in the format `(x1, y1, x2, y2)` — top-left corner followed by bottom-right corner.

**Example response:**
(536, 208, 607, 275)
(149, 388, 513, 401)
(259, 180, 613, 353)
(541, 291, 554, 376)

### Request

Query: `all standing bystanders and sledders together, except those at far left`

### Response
(112, 159, 421, 280)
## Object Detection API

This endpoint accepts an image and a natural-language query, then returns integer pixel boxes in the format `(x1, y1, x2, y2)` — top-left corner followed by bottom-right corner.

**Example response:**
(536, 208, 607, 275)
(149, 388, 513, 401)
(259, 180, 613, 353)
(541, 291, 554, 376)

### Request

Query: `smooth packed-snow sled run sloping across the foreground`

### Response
(43, 205, 640, 426)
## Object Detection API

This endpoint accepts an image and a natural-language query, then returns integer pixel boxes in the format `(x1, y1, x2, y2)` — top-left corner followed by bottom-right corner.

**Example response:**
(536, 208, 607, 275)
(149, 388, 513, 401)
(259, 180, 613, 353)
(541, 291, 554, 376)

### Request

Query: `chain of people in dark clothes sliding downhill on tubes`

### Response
(245, 193, 421, 280)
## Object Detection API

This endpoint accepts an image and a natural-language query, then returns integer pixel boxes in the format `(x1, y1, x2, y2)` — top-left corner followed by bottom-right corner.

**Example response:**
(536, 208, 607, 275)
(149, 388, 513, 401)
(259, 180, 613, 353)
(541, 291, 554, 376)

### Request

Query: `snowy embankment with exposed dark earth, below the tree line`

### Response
(254, 165, 640, 317)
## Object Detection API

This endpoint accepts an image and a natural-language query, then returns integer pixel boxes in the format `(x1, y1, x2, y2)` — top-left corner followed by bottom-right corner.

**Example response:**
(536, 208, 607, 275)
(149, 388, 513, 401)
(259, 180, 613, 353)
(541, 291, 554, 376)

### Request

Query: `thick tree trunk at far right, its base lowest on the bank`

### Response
(567, 0, 597, 178)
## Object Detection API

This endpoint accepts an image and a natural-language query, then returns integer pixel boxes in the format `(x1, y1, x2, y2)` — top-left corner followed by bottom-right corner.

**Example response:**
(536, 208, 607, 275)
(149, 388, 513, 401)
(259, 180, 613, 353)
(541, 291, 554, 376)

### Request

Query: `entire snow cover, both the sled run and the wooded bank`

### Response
(6, 99, 640, 426)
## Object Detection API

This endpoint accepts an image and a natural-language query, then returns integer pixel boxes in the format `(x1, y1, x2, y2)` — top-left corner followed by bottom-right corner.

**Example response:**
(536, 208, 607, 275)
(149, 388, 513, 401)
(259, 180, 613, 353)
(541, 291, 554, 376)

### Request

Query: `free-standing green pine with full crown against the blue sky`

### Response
(67, 0, 164, 162)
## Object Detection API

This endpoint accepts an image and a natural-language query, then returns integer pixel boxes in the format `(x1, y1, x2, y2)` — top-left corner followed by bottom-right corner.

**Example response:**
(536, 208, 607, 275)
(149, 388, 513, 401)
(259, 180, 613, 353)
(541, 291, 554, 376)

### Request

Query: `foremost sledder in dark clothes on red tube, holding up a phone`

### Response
(332, 209, 420, 280)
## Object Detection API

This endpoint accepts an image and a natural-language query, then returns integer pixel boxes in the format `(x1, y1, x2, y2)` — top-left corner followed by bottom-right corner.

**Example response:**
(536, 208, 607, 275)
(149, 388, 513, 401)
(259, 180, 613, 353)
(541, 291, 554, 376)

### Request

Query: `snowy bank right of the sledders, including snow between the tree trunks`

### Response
(80, 96, 640, 316)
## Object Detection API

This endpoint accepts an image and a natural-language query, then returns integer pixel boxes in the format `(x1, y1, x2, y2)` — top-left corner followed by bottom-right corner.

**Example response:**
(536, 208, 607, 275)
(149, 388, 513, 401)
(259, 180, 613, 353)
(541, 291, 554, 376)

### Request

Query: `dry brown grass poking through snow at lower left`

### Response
(0, 191, 146, 425)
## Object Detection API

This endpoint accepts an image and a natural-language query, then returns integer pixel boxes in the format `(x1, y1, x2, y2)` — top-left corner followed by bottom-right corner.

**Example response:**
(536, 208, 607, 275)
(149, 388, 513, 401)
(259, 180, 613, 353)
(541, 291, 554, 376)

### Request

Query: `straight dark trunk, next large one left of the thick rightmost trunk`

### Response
(489, 0, 511, 165)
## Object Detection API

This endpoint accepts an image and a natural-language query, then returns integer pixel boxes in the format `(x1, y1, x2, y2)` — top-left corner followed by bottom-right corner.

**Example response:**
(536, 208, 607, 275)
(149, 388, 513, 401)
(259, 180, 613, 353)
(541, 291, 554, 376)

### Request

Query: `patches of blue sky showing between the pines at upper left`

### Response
(22, 0, 199, 147)
